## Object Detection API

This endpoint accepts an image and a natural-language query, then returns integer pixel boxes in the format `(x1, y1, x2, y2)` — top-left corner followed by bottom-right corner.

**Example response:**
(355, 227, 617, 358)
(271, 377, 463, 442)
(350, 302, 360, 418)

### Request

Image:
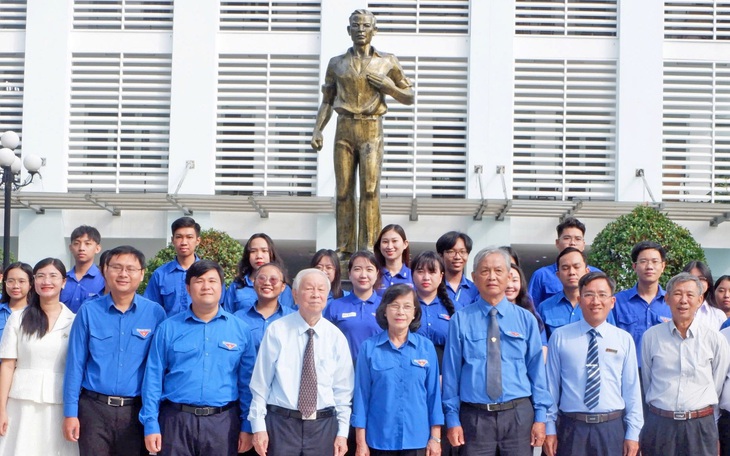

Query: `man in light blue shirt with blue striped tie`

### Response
(543, 272, 644, 456)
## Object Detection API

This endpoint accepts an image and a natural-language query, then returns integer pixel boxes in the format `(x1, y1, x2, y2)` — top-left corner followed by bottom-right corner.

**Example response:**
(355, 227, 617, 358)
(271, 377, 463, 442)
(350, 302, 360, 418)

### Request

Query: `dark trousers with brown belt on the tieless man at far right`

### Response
(640, 412, 718, 456)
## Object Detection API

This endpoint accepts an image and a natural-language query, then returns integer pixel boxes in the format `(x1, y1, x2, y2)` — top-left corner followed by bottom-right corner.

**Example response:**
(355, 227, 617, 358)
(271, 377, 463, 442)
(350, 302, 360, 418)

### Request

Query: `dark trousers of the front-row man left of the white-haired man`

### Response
(160, 402, 241, 456)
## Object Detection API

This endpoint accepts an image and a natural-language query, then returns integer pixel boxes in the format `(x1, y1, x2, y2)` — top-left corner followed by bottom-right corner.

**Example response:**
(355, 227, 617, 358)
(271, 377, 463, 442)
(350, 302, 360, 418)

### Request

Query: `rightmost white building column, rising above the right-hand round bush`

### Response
(616, 0, 664, 201)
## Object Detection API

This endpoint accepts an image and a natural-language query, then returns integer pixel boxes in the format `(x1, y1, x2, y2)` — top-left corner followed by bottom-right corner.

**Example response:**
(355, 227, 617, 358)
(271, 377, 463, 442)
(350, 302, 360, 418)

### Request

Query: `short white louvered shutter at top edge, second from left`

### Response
(73, 0, 173, 30)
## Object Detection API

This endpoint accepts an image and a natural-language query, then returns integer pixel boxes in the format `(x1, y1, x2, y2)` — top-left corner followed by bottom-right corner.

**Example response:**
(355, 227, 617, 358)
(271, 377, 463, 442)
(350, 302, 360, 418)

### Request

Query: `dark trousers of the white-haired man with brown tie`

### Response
(266, 411, 337, 456)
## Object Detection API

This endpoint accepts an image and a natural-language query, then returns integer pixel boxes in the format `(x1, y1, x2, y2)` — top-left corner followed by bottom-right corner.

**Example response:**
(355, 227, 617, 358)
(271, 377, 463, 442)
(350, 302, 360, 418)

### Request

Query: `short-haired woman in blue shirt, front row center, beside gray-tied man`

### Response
(351, 284, 444, 456)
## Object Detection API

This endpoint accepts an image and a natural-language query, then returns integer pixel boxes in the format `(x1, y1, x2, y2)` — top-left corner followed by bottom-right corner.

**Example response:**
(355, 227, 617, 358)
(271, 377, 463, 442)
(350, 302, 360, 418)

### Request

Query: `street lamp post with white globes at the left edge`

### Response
(0, 131, 43, 271)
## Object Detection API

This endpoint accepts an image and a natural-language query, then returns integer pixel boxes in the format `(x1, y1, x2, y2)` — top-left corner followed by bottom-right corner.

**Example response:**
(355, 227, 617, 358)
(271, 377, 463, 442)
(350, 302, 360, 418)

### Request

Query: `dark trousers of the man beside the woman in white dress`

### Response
(79, 393, 148, 456)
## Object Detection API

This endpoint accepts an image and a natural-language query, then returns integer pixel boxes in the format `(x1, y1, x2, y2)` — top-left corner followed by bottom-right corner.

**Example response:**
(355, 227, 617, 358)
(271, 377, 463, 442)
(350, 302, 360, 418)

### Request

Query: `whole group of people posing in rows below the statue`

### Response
(0, 217, 730, 456)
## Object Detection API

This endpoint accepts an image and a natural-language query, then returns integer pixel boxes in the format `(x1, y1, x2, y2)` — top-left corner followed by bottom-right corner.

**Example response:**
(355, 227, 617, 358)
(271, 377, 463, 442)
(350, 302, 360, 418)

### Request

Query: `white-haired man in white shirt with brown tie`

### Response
(248, 269, 355, 456)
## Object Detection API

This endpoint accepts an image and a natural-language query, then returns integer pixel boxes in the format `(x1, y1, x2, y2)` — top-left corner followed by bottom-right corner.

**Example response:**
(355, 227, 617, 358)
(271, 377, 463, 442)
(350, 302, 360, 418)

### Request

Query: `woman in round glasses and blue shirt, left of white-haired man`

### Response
(235, 263, 294, 353)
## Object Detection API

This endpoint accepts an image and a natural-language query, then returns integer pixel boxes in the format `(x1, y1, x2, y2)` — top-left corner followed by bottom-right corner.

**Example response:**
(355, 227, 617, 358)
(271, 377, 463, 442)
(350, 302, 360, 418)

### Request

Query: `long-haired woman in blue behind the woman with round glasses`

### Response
(223, 233, 294, 313)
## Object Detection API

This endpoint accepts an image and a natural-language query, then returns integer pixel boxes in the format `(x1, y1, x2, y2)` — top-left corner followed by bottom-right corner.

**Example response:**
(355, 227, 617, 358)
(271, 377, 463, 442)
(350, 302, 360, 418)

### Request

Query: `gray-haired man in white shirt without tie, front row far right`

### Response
(640, 272, 730, 456)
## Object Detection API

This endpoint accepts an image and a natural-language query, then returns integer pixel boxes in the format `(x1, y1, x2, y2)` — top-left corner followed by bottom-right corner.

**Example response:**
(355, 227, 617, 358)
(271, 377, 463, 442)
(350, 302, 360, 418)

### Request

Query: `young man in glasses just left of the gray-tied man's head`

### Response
(436, 231, 479, 309)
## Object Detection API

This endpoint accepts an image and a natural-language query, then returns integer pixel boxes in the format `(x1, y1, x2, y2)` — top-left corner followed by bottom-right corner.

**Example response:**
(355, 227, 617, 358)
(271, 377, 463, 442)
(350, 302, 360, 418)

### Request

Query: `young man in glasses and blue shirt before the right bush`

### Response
(613, 241, 672, 368)
